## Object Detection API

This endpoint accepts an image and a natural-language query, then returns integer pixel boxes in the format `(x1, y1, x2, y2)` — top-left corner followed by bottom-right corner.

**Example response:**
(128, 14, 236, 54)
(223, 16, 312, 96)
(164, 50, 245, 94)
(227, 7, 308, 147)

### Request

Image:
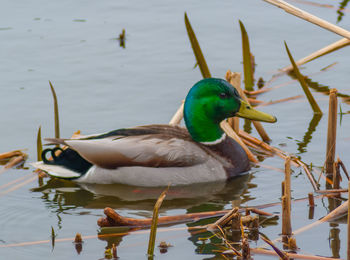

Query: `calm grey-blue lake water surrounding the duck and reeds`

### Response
(0, 0, 350, 259)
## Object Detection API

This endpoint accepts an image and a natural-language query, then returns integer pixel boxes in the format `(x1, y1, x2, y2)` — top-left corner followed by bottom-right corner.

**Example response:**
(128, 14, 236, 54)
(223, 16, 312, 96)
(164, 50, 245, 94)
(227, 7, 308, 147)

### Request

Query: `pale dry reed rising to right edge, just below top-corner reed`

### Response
(281, 38, 350, 72)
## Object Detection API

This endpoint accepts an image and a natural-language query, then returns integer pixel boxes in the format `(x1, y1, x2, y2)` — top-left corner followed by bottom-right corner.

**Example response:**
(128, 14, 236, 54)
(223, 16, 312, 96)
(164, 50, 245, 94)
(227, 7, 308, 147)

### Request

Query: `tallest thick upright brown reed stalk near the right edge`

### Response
(326, 89, 338, 177)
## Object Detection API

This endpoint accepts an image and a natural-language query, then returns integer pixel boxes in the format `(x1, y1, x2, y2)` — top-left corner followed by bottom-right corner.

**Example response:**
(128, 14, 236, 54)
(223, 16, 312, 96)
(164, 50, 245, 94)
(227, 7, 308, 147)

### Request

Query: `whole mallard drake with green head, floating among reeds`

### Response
(34, 78, 276, 187)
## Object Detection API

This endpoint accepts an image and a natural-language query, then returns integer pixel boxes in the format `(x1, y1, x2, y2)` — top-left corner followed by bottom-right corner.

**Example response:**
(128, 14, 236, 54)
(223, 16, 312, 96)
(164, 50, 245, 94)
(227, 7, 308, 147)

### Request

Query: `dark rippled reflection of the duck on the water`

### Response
(33, 174, 256, 252)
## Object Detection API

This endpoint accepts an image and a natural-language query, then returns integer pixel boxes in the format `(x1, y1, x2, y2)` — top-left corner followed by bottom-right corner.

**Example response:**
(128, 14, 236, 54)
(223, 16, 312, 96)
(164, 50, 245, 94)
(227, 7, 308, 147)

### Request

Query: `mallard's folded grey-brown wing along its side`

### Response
(64, 135, 208, 169)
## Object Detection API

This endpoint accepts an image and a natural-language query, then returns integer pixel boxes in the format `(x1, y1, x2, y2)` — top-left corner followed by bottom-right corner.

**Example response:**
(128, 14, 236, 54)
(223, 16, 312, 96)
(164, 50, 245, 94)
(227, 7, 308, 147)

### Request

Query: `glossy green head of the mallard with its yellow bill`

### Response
(184, 78, 277, 143)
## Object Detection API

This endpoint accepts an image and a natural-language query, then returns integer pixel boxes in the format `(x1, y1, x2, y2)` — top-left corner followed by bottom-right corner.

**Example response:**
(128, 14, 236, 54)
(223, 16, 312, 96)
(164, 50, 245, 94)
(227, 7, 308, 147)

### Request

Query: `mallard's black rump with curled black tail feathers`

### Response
(41, 147, 92, 174)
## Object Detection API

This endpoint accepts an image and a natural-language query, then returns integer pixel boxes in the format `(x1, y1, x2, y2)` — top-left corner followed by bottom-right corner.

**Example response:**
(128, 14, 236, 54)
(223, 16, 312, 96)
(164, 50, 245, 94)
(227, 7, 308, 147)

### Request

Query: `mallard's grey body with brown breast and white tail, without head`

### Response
(34, 125, 250, 187)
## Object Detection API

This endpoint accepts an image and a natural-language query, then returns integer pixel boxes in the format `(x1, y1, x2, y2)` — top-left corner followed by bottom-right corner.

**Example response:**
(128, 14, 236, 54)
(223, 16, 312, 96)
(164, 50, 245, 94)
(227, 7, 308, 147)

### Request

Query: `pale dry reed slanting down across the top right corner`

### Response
(264, 0, 350, 39)
